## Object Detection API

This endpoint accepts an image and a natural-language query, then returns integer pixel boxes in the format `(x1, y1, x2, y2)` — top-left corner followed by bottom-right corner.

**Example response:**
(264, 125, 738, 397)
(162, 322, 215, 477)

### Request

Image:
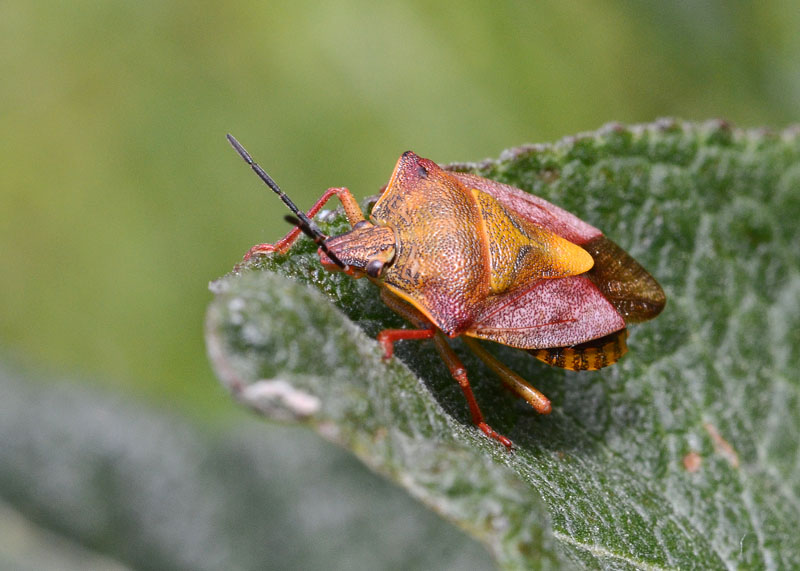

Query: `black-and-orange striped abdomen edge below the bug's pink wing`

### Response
(528, 329, 628, 371)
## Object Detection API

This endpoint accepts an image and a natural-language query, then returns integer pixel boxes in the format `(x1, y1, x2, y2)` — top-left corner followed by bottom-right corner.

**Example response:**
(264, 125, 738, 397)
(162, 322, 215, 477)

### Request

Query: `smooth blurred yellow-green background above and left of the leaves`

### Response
(0, 0, 800, 568)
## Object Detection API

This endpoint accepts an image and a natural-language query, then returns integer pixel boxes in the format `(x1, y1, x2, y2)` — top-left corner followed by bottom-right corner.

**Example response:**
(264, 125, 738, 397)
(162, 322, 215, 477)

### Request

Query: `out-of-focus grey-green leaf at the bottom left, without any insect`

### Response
(0, 366, 490, 571)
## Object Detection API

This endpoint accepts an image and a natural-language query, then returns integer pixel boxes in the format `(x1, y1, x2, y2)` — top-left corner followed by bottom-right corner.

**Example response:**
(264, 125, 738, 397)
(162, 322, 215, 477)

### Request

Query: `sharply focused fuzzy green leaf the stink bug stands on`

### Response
(207, 120, 800, 569)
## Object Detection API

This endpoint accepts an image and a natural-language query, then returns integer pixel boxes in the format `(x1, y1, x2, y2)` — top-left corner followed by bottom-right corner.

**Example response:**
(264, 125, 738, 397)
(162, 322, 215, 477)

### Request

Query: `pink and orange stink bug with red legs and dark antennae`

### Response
(228, 135, 666, 449)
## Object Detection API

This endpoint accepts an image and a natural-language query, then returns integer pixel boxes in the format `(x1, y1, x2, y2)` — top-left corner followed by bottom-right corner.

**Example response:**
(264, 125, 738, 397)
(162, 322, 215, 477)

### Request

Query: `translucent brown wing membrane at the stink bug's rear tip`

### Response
(582, 235, 667, 323)
